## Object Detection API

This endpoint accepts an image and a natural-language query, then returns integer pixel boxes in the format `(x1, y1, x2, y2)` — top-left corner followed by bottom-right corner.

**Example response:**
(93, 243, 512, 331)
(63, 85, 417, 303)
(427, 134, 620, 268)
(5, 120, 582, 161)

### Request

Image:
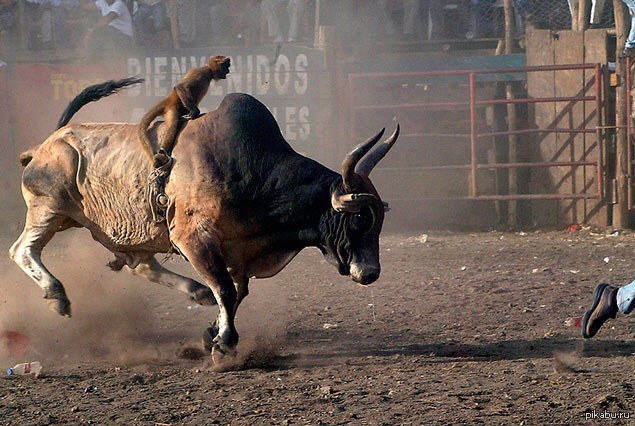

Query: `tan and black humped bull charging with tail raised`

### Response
(9, 80, 399, 362)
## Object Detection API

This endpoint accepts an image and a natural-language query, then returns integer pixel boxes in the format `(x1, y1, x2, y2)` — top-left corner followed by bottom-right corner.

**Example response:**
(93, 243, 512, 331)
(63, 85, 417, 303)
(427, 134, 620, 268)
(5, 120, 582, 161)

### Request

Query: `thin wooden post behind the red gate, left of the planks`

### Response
(503, 0, 518, 227)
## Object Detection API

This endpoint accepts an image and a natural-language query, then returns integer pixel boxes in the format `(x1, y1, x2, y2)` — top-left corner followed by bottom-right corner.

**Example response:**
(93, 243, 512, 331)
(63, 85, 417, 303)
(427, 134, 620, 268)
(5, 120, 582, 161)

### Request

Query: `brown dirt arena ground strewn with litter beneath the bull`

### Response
(0, 230, 635, 425)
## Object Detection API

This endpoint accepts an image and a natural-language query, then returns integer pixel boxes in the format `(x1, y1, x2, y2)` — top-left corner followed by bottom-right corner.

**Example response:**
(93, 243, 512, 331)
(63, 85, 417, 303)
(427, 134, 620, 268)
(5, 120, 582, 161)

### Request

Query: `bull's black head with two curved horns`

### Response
(320, 125, 399, 284)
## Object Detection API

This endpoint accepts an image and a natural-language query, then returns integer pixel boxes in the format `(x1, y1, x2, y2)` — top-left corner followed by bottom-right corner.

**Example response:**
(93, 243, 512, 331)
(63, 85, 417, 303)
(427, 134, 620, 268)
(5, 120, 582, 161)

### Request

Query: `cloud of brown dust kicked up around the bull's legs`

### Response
(0, 230, 289, 370)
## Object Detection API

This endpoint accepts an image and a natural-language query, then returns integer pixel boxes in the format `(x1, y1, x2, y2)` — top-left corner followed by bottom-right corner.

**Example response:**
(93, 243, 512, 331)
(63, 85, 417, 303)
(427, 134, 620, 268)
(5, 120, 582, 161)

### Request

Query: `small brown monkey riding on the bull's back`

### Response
(139, 55, 230, 169)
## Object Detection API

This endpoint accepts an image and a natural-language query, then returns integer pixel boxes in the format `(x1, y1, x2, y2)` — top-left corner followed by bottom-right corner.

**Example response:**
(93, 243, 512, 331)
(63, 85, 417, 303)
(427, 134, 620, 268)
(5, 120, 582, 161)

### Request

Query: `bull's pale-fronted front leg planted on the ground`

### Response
(171, 223, 238, 363)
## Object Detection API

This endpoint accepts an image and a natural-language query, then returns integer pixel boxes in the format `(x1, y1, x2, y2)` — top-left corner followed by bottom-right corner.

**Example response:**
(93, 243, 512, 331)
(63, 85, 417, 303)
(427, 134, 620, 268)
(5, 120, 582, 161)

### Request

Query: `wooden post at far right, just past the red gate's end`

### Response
(613, 0, 631, 229)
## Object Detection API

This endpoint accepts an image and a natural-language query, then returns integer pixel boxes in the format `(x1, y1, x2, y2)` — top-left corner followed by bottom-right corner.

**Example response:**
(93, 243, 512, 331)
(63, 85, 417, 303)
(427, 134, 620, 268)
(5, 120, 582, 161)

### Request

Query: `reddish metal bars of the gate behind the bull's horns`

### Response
(347, 64, 607, 205)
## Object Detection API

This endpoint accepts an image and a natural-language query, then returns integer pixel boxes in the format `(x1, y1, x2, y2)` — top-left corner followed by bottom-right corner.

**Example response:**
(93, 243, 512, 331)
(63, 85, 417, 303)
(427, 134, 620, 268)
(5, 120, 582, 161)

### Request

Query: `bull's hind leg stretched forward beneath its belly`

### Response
(125, 256, 216, 305)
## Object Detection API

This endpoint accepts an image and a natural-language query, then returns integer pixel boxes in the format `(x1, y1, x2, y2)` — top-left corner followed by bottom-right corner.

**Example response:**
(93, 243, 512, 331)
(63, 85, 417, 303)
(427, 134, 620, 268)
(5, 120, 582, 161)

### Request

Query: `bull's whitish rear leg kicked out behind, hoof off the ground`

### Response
(9, 206, 74, 317)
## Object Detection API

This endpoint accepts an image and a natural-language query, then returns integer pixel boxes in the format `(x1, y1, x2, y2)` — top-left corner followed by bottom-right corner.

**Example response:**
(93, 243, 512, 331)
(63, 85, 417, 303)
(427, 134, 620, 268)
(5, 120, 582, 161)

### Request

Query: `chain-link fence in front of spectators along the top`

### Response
(0, 0, 614, 51)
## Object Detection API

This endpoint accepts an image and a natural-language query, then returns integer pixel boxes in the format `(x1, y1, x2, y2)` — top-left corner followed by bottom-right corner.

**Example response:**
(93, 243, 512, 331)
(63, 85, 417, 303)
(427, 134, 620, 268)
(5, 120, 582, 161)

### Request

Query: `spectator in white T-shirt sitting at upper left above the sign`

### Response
(82, 0, 134, 58)
